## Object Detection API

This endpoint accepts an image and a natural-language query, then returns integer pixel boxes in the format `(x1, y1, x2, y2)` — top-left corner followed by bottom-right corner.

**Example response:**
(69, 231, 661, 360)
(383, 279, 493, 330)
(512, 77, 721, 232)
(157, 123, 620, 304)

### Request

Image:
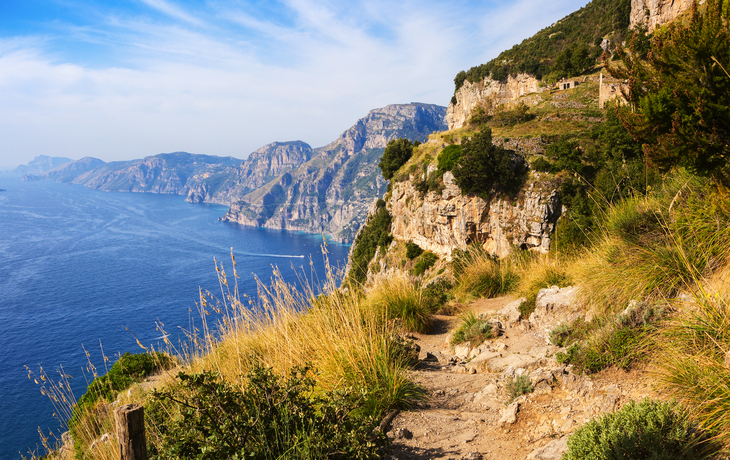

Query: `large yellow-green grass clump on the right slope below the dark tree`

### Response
(576, 174, 730, 312)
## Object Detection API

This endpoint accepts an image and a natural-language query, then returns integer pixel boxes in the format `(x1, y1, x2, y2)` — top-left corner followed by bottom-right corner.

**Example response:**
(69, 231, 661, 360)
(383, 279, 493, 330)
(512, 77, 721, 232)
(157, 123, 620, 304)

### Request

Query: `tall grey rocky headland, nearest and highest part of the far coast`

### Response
(223, 104, 446, 241)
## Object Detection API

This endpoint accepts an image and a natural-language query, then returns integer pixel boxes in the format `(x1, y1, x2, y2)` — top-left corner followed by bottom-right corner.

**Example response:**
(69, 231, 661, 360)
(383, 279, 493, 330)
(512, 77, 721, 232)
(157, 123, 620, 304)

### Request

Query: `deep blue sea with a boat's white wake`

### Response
(0, 174, 348, 459)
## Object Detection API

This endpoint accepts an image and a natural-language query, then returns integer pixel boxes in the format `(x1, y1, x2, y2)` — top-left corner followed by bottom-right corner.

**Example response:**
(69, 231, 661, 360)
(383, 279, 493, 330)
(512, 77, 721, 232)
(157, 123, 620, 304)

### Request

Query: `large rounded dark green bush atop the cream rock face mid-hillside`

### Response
(452, 128, 527, 196)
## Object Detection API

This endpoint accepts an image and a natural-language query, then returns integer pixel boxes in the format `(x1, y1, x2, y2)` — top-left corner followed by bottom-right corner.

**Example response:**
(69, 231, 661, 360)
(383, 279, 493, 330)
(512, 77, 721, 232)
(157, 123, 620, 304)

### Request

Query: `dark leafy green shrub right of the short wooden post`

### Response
(147, 366, 385, 460)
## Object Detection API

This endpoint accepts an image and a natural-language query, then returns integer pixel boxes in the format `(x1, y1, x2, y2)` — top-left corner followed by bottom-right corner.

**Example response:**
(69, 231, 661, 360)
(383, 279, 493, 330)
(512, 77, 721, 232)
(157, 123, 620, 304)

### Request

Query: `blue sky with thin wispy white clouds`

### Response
(0, 0, 587, 169)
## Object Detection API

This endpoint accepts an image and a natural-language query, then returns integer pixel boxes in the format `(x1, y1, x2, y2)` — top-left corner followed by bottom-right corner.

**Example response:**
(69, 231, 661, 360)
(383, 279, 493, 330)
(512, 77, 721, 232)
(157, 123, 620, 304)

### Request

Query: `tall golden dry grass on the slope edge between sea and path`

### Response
(30, 250, 424, 460)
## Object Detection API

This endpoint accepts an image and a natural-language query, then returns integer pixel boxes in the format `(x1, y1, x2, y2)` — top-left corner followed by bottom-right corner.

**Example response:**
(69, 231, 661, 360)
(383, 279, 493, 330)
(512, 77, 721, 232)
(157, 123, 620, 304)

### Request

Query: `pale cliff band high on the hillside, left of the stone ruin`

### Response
(446, 74, 547, 129)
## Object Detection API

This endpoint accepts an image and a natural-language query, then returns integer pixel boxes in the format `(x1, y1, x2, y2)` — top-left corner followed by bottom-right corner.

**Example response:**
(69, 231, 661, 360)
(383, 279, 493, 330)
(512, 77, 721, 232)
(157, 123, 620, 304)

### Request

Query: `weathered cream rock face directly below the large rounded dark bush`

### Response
(388, 172, 561, 256)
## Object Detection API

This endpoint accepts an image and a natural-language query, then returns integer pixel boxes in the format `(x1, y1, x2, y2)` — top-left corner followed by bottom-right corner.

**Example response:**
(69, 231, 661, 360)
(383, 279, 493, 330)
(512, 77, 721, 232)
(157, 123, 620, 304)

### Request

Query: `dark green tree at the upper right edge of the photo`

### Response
(604, 0, 730, 185)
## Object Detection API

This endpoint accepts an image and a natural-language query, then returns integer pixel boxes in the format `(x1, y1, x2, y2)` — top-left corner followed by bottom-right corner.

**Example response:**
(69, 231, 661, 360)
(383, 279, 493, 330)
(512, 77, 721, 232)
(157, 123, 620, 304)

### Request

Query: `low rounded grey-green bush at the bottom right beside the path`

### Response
(563, 399, 720, 460)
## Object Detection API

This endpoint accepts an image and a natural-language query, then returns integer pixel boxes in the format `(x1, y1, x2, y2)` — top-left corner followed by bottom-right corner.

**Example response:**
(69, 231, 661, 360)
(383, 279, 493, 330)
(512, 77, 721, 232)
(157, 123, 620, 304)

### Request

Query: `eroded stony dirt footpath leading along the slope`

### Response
(388, 294, 656, 460)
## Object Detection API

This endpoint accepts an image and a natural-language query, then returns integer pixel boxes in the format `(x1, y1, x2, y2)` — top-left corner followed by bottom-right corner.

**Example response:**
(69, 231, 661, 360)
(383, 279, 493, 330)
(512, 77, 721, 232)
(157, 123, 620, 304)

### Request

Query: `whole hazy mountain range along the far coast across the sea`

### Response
(64, 103, 446, 241)
